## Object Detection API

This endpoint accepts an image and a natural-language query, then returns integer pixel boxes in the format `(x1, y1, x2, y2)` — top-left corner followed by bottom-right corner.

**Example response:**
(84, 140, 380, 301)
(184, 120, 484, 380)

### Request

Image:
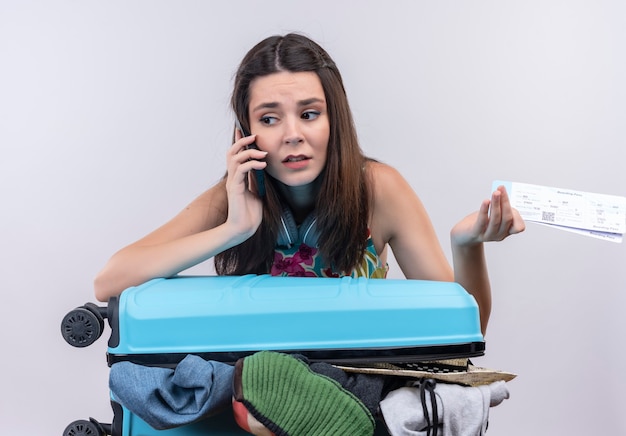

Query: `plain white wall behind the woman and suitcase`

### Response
(0, 0, 626, 436)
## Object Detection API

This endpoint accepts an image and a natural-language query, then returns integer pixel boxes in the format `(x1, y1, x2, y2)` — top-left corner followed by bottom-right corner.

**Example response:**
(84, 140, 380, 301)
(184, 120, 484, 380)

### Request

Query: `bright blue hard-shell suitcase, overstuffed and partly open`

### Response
(61, 275, 485, 436)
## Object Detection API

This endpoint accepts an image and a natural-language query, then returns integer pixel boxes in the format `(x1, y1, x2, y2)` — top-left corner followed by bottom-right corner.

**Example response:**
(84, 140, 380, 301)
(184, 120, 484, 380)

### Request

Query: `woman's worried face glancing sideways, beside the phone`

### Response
(248, 72, 330, 186)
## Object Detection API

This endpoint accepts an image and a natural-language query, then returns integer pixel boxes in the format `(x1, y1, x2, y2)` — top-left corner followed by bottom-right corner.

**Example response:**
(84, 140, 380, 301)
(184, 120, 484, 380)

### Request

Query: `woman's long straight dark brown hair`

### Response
(215, 33, 369, 275)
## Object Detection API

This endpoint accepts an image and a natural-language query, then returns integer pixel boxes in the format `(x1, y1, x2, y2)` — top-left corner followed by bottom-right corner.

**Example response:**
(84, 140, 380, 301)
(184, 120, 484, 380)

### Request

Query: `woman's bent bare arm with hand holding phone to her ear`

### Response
(94, 136, 266, 301)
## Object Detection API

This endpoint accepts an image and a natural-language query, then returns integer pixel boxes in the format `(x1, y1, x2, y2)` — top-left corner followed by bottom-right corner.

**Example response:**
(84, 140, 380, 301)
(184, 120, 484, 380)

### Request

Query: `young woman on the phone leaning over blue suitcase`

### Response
(95, 34, 524, 332)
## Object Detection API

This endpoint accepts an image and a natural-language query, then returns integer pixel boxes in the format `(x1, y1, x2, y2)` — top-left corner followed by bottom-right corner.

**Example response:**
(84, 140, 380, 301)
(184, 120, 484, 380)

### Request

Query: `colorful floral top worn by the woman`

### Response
(271, 235, 389, 279)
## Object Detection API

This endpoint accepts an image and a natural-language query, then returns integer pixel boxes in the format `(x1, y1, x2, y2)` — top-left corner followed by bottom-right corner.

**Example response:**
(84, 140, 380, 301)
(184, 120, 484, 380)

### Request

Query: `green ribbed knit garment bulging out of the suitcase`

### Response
(234, 351, 374, 436)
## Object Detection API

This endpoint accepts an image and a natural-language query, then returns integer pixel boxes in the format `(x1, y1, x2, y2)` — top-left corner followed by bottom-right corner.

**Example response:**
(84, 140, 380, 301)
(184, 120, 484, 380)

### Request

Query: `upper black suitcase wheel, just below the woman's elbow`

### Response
(61, 303, 104, 348)
